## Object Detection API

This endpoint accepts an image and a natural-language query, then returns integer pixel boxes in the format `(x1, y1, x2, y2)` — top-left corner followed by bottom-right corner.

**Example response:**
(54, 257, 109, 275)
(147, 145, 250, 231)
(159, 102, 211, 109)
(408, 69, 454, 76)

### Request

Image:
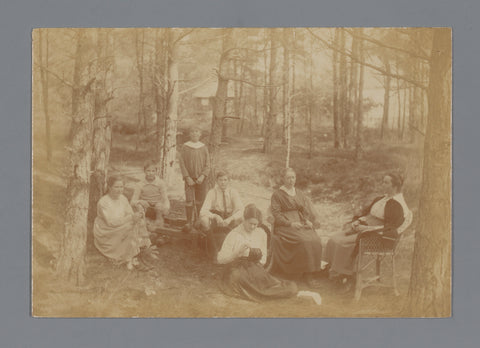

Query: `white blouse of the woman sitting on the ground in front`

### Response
(217, 224, 267, 265)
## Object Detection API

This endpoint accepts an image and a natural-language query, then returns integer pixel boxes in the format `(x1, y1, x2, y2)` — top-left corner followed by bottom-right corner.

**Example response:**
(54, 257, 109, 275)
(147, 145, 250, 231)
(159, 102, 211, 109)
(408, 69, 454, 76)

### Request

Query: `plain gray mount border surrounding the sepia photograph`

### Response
(0, 0, 480, 348)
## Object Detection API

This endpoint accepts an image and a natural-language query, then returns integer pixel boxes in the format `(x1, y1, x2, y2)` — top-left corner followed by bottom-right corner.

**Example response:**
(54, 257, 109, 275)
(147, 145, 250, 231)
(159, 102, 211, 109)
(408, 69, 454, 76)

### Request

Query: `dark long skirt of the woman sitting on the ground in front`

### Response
(222, 259, 298, 301)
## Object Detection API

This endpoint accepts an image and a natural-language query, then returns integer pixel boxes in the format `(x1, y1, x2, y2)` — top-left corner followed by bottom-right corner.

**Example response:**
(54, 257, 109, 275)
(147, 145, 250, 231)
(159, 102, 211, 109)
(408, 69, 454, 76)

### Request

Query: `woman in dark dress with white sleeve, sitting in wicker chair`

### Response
(326, 173, 409, 290)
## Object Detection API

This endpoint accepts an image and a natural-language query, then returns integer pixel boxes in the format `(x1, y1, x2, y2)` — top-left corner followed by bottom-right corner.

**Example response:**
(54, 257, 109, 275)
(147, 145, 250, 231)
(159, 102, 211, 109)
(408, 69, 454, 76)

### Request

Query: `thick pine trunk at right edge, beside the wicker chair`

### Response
(407, 28, 452, 317)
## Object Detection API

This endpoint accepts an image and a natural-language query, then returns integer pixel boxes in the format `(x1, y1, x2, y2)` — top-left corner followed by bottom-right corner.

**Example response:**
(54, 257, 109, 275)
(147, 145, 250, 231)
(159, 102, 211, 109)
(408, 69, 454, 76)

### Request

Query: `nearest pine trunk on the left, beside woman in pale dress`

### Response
(57, 29, 94, 285)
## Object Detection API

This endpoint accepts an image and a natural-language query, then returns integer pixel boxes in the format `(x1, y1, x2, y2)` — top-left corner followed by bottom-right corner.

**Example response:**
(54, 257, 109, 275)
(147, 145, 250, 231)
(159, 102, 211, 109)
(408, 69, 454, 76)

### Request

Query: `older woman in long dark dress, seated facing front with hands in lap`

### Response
(271, 168, 322, 287)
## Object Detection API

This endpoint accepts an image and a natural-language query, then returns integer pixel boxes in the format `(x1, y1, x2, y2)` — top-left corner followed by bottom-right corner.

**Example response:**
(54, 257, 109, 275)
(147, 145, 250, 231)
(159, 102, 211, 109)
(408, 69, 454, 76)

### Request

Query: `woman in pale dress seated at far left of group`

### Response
(93, 176, 150, 269)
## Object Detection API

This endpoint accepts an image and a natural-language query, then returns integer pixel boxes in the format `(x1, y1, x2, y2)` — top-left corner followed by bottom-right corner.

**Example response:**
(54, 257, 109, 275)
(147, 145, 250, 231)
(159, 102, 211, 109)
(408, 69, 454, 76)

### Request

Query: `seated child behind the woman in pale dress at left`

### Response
(130, 160, 170, 230)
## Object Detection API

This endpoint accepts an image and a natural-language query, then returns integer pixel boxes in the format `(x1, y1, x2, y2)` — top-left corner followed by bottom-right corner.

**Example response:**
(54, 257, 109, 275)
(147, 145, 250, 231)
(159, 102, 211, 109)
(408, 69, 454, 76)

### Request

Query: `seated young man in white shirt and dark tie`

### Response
(199, 171, 243, 258)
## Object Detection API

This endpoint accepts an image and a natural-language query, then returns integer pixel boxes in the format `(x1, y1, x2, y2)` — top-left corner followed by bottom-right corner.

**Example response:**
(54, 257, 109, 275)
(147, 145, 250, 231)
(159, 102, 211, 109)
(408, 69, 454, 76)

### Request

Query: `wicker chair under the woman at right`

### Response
(355, 211, 413, 301)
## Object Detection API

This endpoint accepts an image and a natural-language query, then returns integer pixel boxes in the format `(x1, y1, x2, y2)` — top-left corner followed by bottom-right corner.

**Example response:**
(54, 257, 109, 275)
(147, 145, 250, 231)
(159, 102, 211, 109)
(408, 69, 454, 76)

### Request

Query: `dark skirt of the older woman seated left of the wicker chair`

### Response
(272, 226, 322, 274)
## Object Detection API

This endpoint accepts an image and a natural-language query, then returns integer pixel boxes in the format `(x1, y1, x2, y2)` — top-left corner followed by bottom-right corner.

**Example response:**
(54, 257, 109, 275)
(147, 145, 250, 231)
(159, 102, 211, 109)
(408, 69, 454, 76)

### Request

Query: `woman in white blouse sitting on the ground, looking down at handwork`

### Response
(217, 204, 297, 301)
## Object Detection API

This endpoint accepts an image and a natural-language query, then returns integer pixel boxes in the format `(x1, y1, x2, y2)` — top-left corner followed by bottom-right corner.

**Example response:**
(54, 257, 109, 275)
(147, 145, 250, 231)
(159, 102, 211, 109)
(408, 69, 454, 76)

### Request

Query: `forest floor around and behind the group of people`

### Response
(32, 131, 421, 317)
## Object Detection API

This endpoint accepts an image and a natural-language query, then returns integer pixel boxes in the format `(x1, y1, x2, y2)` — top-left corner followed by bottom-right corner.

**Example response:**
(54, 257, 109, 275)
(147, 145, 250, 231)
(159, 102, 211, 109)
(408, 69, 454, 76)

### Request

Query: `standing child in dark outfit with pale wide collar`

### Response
(180, 127, 210, 229)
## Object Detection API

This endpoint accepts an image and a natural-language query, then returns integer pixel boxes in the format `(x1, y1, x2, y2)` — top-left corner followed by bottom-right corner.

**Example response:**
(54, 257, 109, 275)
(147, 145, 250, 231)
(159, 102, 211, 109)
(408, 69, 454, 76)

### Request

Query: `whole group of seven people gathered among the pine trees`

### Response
(93, 126, 409, 300)
